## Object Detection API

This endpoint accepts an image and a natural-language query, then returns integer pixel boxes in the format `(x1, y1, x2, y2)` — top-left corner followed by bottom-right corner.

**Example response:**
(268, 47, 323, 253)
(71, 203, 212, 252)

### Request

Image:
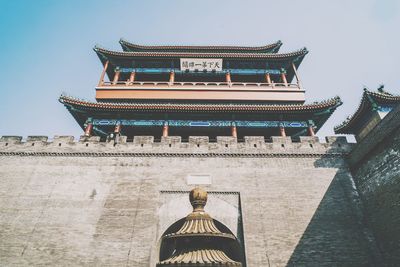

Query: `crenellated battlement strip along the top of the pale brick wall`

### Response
(0, 135, 353, 156)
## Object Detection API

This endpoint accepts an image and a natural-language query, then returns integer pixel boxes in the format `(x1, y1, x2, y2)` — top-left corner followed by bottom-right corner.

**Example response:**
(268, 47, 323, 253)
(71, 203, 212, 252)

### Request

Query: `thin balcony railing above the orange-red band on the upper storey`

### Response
(99, 81, 300, 89)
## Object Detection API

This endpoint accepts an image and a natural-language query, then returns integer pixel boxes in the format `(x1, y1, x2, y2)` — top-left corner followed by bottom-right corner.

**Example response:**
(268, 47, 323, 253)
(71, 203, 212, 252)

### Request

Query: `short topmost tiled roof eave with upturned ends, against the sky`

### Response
(119, 38, 282, 53)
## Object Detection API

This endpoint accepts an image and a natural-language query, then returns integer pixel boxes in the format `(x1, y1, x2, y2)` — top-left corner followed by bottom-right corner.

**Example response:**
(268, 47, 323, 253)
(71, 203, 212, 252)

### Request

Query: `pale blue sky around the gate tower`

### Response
(0, 0, 400, 141)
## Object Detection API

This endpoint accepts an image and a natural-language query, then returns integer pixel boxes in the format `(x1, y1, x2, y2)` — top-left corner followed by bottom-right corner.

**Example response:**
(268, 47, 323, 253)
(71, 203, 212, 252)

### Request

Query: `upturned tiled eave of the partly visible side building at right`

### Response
(334, 89, 400, 134)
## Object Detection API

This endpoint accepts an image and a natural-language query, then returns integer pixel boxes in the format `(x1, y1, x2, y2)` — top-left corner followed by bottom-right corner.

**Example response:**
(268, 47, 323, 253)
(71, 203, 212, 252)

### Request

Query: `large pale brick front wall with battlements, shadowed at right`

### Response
(0, 136, 381, 267)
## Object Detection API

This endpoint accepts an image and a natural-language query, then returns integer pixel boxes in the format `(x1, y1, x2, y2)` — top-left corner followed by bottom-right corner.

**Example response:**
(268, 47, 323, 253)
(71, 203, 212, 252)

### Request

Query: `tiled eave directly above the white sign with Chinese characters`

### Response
(94, 46, 308, 60)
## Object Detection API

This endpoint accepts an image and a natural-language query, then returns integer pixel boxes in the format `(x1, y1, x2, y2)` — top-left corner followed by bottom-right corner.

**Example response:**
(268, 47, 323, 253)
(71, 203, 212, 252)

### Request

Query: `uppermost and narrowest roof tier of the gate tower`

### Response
(119, 39, 282, 53)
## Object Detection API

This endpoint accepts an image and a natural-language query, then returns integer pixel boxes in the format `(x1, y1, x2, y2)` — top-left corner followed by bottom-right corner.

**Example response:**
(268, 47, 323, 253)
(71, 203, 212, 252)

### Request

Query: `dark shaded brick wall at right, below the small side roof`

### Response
(349, 106, 400, 266)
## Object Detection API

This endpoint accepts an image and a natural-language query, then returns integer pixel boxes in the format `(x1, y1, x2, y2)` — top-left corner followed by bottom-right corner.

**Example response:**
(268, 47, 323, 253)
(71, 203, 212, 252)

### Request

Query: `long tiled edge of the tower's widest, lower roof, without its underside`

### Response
(59, 95, 342, 113)
